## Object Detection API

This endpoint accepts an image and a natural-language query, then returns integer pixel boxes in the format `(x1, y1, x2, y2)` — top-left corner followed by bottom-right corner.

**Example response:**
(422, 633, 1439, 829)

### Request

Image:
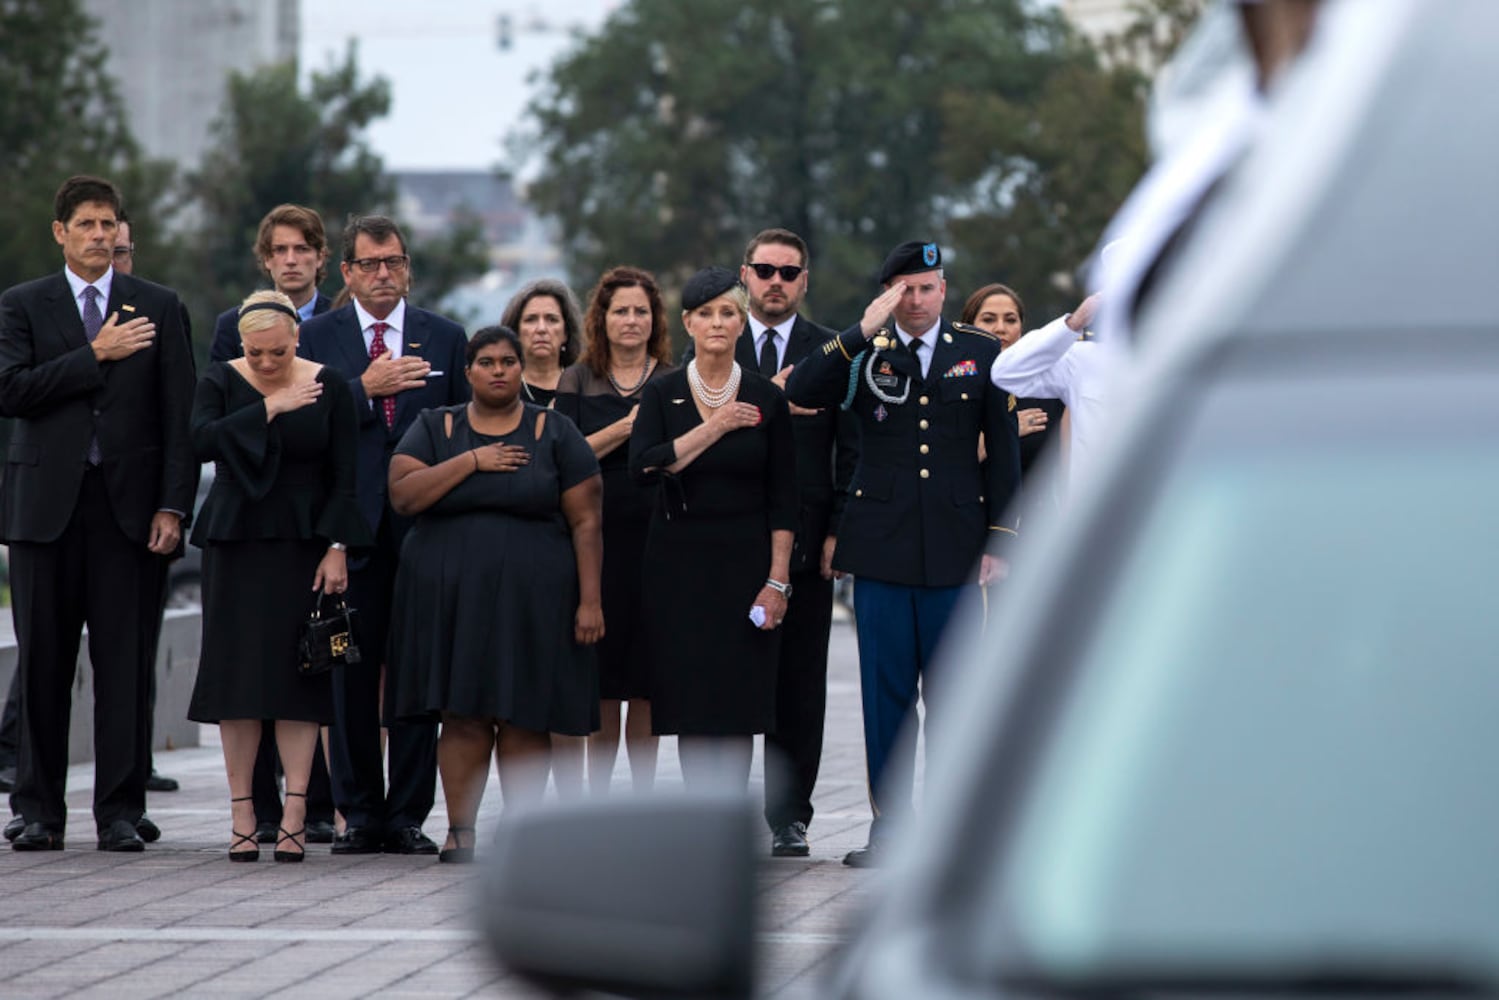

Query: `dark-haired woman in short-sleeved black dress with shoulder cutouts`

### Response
(390, 327, 604, 861)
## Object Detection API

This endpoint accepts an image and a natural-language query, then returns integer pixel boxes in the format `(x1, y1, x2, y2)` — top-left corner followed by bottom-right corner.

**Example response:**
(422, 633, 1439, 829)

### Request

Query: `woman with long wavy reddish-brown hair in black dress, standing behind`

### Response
(553, 267, 672, 795)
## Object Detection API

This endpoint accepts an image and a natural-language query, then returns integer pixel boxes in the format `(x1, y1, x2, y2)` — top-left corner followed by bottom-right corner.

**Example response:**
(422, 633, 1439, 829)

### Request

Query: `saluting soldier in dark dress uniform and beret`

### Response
(785, 241, 1021, 868)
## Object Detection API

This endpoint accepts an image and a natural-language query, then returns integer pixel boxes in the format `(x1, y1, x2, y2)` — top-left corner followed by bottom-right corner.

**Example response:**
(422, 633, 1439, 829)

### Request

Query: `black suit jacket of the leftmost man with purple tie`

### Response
(0, 271, 198, 546)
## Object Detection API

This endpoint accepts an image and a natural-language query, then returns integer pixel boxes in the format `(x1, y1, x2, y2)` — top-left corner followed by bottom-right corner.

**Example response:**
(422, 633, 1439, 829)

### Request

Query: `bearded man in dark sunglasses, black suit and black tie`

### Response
(684, 229, 857, 858)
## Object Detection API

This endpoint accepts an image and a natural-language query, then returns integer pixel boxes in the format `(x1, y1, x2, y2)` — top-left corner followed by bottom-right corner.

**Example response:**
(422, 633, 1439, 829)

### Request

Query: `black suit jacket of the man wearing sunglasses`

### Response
(682, 316, 859, 573)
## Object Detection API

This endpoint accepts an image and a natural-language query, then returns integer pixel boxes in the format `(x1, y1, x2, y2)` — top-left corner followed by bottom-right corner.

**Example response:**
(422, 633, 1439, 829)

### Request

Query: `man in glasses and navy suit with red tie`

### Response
(297, 216, 469, 855)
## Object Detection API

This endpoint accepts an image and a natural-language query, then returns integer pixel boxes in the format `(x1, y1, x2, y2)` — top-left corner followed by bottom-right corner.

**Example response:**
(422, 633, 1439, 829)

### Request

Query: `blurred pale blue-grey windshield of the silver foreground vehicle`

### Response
(989, 375, 1499, 978)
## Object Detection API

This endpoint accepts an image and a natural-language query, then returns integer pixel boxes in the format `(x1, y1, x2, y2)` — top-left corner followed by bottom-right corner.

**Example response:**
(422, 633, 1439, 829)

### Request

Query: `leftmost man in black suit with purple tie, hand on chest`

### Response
(0, 177, 196, 852)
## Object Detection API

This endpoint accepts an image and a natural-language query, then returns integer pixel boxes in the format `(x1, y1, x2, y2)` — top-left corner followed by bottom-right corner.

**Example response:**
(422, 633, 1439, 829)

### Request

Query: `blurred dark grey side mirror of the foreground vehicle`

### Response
(481, 796, 755, 999)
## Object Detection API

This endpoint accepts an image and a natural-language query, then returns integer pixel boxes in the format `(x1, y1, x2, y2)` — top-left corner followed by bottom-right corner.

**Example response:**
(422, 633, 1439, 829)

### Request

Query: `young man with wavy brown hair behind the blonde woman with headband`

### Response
(208, 205, 333, 361)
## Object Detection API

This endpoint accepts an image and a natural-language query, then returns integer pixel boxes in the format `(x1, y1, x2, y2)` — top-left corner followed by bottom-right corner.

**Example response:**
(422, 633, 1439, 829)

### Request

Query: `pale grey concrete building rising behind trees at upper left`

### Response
(84, 0, 301, 169)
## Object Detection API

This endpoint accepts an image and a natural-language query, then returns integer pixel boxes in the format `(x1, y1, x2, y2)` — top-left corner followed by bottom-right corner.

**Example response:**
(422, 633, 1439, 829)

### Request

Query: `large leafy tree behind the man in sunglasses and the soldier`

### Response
(513, 0, 1144, 325)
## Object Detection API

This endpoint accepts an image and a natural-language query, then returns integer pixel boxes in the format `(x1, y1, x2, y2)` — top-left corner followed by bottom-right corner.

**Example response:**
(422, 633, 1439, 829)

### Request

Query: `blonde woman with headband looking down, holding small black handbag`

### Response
(187, 292, 370, 861)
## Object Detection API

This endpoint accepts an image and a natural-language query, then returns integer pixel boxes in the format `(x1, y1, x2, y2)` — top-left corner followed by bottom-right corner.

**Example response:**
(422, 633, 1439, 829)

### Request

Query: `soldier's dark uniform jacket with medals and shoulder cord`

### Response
(785, 319, 1021, 586)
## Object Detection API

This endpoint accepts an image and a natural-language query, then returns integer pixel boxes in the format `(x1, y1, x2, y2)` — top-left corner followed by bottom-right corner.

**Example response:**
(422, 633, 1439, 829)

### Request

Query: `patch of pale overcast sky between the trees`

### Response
(301, 0, 618, 169)
